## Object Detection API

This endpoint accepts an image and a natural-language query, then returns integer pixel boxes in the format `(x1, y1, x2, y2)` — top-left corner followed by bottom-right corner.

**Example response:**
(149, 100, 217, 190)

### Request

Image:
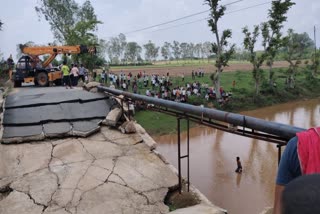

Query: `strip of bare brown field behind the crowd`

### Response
(110, 61, 289, 76)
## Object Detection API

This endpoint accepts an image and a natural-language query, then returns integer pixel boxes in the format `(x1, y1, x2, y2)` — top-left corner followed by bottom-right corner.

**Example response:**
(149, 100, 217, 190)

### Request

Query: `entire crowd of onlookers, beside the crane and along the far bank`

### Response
(61, 64, 232, 105)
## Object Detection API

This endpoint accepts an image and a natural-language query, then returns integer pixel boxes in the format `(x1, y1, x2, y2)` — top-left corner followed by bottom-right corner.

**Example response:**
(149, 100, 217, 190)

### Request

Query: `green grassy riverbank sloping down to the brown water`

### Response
(135, 68, 320, 136)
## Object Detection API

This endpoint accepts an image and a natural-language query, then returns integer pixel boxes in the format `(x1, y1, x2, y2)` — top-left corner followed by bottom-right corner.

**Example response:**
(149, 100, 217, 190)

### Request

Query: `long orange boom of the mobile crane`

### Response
(20, 45, 96, 68)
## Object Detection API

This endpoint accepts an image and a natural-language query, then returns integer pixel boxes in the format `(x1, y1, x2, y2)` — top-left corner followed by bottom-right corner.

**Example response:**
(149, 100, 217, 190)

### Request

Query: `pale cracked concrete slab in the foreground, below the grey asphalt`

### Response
(0, 125, 225, 214)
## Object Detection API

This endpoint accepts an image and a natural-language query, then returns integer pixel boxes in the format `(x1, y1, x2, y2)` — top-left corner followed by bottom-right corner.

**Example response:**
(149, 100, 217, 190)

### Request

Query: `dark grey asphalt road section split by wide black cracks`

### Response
(2, 87, 115, 143)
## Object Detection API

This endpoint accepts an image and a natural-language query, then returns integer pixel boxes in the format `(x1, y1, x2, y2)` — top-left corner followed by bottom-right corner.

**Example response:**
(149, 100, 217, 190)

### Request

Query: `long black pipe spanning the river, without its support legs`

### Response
(98, 86, 305, 140)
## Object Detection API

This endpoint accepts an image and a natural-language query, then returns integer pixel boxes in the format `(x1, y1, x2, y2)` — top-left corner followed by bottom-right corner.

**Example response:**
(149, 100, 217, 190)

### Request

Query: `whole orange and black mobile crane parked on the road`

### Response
(10, 45, 96, 87)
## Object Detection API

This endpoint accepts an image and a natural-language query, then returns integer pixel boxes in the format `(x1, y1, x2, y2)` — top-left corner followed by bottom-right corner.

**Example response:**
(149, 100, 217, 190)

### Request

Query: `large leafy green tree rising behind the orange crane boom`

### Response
(35, 0, 105, 71)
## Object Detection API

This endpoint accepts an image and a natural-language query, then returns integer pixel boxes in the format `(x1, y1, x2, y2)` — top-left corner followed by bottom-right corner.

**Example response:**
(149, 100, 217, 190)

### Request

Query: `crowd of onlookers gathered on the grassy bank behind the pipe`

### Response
(104, 68, 232, 105)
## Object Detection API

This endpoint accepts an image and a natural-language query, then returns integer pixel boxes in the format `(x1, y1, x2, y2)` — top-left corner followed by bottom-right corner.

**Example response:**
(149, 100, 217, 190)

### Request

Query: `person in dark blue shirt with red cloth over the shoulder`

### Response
(273, 127, 320, 214)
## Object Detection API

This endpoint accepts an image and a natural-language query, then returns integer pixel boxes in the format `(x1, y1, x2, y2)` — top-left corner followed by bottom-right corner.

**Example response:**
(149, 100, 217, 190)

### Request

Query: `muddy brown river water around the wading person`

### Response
(153, 99, 320, 214)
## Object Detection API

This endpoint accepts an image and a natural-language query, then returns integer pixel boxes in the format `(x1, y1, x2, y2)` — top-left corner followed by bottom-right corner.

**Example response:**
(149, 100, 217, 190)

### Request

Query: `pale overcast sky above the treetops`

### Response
(0, 0, 320, 59)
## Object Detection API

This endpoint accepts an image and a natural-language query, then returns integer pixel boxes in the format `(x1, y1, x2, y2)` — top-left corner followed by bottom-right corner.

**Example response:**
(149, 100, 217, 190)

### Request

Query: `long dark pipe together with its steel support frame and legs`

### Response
(98, 86, 305, 192)
